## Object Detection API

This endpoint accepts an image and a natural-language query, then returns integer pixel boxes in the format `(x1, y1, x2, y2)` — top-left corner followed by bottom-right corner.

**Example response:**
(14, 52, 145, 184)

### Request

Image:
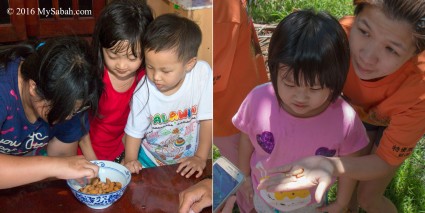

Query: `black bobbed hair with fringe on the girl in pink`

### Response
(268, 10, 350, 106)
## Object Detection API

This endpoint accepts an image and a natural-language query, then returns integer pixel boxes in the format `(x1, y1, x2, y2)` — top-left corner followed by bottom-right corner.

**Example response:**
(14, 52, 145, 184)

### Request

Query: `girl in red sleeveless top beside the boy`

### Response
(79, 0, 153, 162)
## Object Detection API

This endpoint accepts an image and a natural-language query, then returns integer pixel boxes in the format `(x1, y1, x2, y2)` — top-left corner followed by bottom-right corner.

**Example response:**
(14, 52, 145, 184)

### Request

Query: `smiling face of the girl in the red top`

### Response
(102, 41, 142, 80)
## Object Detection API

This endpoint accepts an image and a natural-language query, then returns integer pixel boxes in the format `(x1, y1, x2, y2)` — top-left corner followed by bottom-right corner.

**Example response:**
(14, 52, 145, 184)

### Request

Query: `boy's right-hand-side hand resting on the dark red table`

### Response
(177, 156, 207, 178)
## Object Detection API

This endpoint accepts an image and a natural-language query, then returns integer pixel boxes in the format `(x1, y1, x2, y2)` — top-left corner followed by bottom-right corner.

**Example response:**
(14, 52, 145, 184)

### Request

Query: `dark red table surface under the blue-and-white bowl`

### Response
(0, 160, 212, 213)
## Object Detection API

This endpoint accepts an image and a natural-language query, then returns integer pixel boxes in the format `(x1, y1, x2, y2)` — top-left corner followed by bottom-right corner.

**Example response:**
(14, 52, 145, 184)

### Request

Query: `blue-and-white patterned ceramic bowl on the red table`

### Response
(67, 160, 131, 209)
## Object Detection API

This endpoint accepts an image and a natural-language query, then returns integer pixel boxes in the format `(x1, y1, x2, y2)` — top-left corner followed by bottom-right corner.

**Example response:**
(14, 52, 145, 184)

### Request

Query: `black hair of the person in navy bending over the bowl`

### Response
(0, 37, 101, 124)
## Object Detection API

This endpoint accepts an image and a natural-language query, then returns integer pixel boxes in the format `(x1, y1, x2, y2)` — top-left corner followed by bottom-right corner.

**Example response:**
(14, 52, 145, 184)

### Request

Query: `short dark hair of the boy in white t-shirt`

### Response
(143, 13, 202, 63)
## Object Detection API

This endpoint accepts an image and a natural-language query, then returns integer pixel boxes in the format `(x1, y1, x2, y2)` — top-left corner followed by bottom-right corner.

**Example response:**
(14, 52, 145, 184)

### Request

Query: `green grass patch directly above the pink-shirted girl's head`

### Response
(248, 0, 354, 24)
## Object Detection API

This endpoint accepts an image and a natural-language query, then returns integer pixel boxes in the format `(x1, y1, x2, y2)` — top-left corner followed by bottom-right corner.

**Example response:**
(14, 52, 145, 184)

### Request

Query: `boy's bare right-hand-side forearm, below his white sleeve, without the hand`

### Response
(195, 120, 212, 161)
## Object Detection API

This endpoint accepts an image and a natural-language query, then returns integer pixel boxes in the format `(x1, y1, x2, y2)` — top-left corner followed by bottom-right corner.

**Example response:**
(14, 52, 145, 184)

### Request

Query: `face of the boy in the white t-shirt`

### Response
(145, 50, 196, 95)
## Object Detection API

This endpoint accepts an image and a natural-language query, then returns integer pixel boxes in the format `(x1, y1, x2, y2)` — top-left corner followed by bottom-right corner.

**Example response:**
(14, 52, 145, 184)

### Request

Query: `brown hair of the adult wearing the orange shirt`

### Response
(353, 0, 425, 54)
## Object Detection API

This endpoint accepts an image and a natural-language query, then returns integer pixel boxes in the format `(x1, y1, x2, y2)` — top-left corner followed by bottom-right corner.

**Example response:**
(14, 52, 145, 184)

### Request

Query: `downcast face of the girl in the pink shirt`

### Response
(277, 67, 331, 118)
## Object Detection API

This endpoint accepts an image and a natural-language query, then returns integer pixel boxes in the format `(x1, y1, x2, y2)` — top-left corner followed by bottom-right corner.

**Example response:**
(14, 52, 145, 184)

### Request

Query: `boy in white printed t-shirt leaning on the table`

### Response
(124, 14, 212, 178)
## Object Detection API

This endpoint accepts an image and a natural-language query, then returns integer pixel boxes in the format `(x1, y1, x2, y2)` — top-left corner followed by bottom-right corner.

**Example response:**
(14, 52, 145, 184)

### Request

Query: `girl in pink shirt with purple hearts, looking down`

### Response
(233, 10, 368, 212)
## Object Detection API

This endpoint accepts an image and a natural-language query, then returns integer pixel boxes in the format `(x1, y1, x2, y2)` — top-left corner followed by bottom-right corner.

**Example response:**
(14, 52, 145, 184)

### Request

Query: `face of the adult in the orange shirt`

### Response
(350, 6, 416, 80)
